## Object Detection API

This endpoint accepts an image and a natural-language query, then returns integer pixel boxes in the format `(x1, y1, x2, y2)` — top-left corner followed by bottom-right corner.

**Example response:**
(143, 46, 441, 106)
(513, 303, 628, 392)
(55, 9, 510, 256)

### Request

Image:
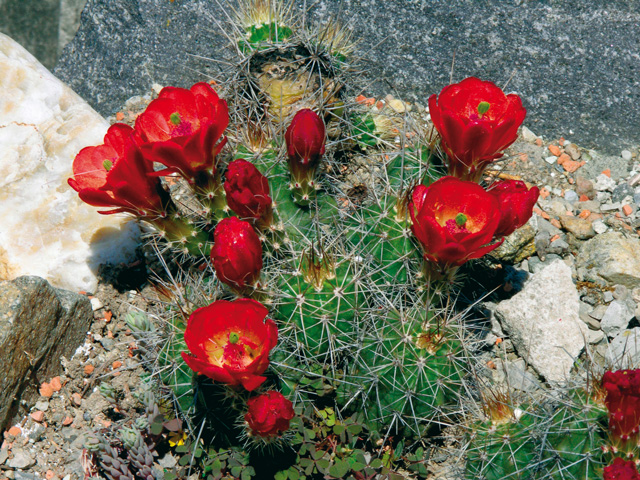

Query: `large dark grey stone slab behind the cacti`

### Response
(53, 0, 640, 154)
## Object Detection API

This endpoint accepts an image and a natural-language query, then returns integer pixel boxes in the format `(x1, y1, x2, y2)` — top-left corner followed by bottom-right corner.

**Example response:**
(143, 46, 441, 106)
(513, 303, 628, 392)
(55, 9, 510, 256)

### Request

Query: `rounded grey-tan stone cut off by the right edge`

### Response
(576, 232, 640, 288)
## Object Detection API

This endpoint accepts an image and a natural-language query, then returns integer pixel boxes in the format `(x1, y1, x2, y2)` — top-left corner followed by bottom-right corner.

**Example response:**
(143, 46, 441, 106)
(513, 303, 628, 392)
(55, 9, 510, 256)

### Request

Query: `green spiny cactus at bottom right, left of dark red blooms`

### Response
(464, 376, 607, 480)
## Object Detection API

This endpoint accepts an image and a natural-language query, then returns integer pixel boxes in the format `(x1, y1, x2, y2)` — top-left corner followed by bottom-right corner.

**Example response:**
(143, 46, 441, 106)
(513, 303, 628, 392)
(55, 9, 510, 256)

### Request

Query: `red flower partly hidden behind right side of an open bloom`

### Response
(487, 180, 540, 237)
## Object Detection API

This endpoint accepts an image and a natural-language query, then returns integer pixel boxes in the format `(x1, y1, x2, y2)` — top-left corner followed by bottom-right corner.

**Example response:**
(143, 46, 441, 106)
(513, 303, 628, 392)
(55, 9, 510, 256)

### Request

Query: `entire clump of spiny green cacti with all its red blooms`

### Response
(70, 0, 640, 480)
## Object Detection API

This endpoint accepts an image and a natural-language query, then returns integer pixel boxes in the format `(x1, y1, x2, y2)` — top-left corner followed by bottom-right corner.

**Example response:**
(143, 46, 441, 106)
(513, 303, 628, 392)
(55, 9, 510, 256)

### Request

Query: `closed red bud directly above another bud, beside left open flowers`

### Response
(224, 159, 272, 224)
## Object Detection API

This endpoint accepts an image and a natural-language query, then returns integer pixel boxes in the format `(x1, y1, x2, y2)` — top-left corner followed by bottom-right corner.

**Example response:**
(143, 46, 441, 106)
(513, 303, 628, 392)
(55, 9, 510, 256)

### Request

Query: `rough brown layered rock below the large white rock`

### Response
(0, 277, 93, 431)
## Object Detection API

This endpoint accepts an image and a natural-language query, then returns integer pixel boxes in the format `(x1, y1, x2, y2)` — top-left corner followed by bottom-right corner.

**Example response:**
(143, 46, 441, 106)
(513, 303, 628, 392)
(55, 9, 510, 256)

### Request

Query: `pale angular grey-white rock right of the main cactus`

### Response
(495, 260, 588, 382)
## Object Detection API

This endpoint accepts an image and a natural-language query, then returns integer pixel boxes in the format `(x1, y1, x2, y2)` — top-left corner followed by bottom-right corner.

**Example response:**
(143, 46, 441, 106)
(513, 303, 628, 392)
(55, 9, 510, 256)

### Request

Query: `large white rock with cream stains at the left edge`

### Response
(0, 34, 139, 291)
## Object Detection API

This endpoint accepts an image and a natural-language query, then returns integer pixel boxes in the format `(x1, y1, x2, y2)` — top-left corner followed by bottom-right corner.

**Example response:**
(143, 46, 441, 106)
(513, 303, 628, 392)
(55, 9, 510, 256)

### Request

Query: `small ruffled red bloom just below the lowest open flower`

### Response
(244, 390, 295, 438)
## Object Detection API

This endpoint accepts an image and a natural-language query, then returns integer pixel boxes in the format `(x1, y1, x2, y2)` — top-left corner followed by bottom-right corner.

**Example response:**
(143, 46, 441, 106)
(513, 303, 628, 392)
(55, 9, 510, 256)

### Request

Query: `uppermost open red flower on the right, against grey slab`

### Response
(429, 77, 527, 181)
